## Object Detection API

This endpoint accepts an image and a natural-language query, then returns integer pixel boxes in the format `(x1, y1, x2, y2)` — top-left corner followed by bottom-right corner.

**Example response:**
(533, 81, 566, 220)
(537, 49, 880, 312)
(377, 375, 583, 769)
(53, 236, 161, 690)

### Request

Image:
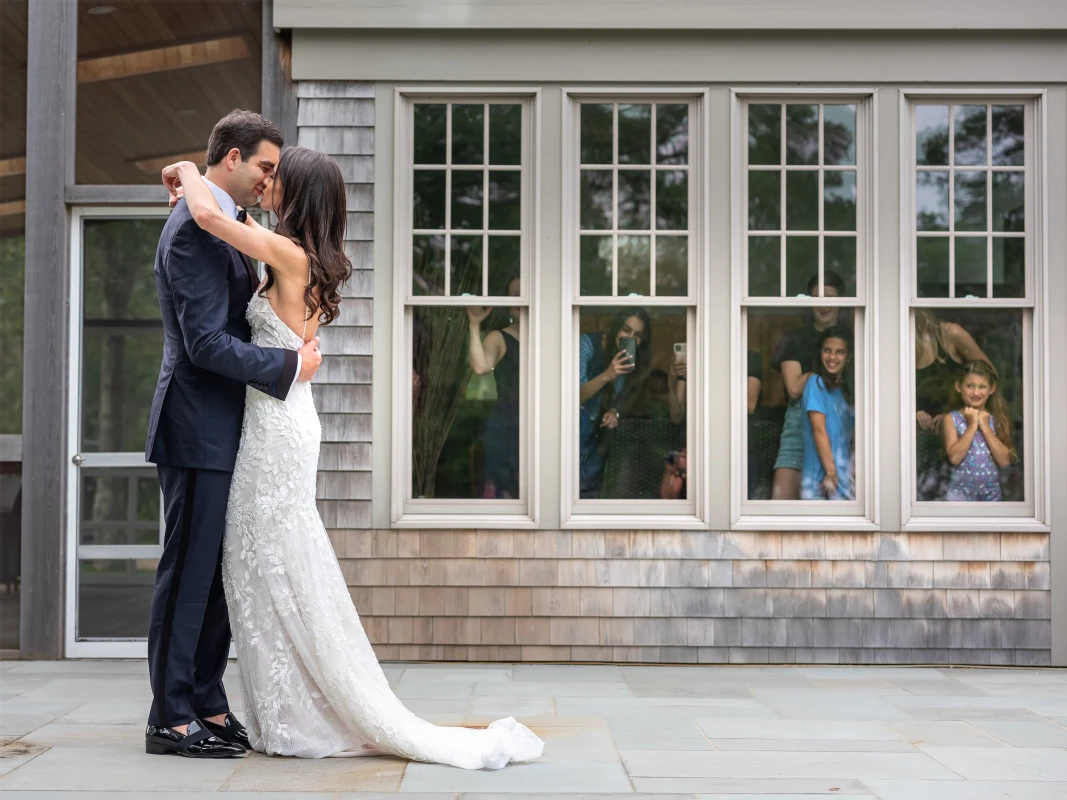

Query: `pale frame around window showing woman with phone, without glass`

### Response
(560, 86, 712, 530)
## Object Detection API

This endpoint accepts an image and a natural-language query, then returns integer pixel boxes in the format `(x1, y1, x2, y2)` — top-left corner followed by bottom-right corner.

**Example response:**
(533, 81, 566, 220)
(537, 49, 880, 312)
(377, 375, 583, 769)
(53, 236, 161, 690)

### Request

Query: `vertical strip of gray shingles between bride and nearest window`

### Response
(297, 81, 375, 533)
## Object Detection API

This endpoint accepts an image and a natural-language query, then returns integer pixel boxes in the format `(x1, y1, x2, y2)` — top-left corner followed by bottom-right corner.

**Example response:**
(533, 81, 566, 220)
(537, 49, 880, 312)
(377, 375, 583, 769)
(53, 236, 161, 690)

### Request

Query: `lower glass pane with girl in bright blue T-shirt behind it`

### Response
(746, 307, 859, 500)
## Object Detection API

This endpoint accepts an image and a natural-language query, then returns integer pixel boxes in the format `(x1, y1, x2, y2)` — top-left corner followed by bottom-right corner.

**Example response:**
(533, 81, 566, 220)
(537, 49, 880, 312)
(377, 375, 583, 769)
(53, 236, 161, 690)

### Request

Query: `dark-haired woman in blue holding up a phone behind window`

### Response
(578, 308, 652, 498)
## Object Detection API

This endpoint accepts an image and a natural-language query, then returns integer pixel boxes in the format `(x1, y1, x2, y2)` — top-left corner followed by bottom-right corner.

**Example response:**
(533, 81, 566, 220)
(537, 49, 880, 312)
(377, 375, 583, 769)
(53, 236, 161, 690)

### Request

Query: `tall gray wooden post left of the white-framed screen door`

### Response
(19, 0, 78, 658)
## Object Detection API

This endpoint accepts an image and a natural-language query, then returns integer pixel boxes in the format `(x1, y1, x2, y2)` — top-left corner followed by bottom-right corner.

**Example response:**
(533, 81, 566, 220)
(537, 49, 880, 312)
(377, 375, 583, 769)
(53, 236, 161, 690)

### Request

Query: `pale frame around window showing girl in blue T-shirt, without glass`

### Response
(730, 86, 880, 531)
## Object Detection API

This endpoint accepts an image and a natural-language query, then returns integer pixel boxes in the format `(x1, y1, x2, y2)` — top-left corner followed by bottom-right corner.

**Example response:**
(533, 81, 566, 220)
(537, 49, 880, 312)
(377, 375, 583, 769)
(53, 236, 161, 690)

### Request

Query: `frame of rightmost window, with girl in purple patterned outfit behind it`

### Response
(899, 87, 1051, 532)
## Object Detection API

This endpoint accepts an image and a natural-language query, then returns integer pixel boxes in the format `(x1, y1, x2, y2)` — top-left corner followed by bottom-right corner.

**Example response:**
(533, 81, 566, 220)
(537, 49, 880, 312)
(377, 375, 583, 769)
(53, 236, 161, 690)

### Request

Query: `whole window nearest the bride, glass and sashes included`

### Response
(394, 93, 536, 525)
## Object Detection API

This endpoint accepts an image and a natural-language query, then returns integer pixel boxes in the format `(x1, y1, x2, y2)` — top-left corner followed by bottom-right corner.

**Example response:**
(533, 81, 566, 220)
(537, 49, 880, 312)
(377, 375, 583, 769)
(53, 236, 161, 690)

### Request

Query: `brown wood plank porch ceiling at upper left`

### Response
(0, 0, 262, 235)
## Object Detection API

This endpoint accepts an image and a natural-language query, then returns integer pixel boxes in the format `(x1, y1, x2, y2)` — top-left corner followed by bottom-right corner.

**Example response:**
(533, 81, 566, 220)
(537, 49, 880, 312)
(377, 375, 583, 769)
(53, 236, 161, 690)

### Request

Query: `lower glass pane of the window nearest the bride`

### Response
(411, 305, 524, 499)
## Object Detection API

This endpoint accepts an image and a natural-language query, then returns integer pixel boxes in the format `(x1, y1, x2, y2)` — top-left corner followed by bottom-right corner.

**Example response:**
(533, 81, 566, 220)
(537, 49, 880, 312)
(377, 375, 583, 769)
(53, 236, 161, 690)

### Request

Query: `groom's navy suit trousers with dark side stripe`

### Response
(148, 464, 233, 725)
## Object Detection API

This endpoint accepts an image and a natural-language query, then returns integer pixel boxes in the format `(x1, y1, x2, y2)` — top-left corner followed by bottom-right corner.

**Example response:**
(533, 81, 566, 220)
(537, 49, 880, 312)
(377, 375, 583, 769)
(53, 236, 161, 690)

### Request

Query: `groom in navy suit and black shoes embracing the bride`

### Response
(145, 111, 322, 758)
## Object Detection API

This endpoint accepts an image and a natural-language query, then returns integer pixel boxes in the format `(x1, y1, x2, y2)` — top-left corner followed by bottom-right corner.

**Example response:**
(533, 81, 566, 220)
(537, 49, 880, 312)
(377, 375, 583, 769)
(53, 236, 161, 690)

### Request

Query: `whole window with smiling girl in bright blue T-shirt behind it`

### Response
(732, 93, 875, 528)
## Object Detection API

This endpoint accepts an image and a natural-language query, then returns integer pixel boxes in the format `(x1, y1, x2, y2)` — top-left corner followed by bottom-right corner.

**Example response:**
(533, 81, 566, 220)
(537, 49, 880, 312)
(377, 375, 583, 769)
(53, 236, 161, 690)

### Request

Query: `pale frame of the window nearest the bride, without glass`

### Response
(391, 86, 541, 528)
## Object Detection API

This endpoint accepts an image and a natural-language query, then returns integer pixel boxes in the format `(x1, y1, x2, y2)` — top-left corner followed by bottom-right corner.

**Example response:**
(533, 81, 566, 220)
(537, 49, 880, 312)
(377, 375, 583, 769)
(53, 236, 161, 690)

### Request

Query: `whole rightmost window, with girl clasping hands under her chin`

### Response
(902, 93, 1044, 530)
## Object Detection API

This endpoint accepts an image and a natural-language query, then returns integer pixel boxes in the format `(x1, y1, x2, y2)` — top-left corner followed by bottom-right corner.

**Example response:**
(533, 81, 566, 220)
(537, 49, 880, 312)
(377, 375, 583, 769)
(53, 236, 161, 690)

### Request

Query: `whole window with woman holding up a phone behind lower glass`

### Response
(561, 91, 705, 527)
